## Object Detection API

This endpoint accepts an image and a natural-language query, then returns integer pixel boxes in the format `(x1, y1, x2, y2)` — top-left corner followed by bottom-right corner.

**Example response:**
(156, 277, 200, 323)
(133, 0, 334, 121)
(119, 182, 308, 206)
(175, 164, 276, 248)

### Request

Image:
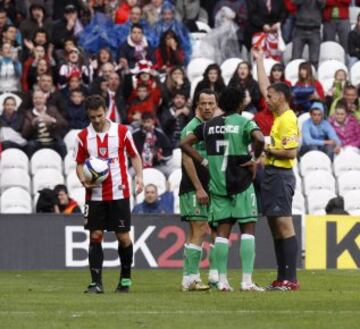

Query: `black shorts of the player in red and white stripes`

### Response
(84, 199, 131, 232)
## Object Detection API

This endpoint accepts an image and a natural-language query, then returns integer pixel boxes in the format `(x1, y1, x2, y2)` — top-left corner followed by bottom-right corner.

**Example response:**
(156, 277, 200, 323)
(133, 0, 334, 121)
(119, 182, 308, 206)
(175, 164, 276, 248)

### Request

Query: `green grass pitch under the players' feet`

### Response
(0, 269, 360, 329)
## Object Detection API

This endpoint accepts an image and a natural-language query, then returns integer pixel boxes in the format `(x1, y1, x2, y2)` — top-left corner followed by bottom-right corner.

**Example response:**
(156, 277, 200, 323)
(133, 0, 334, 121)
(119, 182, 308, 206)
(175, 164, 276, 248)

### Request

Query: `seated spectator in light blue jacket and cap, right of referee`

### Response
(300, 102, 341, 159)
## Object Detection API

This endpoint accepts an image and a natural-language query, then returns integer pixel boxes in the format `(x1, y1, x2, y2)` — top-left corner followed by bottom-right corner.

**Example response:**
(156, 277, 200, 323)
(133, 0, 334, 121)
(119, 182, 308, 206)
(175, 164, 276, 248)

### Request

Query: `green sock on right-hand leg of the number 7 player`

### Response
(240, 234, 255, 284)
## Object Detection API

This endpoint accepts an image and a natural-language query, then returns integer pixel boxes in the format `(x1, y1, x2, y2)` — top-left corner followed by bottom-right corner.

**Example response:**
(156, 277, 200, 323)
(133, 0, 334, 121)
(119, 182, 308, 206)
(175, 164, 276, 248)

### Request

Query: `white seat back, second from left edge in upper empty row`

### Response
(30, 148, 62, 175)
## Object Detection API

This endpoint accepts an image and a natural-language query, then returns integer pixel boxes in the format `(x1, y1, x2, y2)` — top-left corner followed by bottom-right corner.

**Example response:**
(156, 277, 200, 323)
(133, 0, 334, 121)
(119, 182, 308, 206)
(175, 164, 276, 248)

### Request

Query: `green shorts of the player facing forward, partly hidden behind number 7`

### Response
(180, 191, 209, 221)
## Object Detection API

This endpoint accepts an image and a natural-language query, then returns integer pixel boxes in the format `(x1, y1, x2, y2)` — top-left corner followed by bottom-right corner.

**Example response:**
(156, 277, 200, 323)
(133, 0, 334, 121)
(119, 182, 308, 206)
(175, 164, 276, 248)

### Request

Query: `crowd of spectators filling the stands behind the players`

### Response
(0, 0, 360, 211)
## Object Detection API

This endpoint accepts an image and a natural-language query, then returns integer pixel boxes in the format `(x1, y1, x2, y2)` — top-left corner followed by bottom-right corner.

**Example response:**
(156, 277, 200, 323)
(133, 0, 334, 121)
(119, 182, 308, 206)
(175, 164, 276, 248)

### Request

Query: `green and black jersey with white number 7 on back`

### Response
(194, 113, 259, 196)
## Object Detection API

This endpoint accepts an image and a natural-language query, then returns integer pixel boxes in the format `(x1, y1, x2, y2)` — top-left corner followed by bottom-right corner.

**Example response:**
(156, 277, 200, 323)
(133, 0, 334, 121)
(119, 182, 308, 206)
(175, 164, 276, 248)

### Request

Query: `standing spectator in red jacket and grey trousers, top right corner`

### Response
(323, 0, 351, 52)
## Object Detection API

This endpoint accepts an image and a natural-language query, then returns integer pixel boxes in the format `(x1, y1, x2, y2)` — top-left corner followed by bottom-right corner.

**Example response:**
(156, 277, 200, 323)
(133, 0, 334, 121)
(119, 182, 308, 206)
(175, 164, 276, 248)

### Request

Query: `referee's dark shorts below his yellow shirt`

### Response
(261, 166, 296, 217)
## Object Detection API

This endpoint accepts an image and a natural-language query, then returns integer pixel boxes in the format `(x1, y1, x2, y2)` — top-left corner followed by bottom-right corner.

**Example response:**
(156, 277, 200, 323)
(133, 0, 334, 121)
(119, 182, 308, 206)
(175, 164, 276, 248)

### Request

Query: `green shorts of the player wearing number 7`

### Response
(209, 184, 258, 224)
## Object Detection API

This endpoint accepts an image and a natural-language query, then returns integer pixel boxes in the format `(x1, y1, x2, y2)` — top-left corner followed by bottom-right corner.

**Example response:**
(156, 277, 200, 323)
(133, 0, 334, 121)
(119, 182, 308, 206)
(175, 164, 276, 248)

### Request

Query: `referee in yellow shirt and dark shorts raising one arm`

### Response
(253, 49, 300, 291)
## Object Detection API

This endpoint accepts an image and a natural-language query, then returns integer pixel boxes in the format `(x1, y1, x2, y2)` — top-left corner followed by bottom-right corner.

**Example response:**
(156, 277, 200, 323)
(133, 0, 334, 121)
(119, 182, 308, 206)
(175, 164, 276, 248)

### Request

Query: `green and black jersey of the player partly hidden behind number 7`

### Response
(179, 117, 209, 195)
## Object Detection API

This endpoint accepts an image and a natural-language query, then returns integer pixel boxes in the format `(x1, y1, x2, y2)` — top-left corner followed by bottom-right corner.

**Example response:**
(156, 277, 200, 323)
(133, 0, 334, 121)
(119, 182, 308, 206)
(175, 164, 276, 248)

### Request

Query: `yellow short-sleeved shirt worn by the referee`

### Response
(265, 109, 300, 168)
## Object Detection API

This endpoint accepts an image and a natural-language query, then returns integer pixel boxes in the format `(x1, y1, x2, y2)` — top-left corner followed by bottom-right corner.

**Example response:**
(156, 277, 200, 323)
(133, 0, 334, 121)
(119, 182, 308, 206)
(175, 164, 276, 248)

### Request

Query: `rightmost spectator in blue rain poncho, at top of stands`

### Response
(154, 2, 191, 64)
